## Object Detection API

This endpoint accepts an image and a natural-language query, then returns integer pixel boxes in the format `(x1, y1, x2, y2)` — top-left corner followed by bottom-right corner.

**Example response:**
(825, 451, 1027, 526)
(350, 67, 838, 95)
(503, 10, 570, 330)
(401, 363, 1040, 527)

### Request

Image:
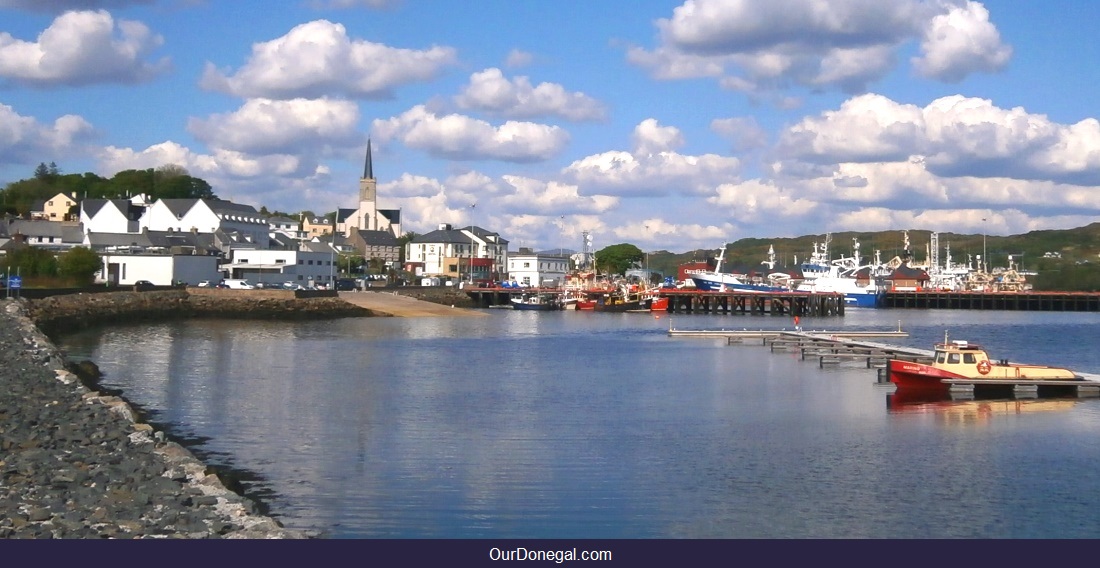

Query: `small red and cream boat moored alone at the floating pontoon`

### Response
(887, 338, 1095, 392)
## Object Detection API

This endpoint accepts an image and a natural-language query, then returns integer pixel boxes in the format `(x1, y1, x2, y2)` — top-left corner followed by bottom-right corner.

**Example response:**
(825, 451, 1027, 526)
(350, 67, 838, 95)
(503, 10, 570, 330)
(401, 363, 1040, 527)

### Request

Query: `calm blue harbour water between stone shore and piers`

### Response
(62, 309, 1100, 538)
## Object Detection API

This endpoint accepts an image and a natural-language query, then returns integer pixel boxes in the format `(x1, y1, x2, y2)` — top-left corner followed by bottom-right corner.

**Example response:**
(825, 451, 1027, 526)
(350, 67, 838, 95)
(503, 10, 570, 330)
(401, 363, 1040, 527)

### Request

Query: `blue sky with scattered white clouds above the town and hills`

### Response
(0, 0, 1100, 253)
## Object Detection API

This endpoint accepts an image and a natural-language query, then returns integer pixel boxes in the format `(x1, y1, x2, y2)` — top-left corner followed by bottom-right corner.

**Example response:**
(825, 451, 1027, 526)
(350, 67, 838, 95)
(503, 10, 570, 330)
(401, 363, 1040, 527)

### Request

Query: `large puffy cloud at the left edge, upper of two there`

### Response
(0, 10, 169, 87)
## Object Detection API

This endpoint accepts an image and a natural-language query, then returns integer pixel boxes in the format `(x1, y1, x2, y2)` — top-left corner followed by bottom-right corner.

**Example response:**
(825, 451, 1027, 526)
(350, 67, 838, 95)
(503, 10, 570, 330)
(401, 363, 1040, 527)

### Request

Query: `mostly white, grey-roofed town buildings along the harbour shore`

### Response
(0, 196, 570, 286)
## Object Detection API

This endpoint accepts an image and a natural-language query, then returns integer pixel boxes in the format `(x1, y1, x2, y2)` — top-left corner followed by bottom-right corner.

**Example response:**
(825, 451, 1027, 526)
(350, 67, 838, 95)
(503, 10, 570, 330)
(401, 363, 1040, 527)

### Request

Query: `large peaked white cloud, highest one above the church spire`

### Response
(200, 20, 455, 99)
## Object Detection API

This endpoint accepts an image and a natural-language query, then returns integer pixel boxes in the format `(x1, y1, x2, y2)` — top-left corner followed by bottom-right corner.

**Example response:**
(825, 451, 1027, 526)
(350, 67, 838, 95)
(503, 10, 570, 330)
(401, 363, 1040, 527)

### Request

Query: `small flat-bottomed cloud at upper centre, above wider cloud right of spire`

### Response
(454, 68, 607, 121)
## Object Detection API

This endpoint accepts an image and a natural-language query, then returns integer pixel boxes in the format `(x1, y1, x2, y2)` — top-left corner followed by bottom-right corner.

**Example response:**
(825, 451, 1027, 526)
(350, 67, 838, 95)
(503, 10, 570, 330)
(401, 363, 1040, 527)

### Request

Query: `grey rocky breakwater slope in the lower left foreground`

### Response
(0, 296, 308, 538)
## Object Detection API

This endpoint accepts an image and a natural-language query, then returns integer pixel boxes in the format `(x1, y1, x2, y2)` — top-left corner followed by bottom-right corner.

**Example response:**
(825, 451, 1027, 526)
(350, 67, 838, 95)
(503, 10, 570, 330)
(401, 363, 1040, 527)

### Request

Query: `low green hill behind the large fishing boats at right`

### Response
(649, 222, 1100, 292)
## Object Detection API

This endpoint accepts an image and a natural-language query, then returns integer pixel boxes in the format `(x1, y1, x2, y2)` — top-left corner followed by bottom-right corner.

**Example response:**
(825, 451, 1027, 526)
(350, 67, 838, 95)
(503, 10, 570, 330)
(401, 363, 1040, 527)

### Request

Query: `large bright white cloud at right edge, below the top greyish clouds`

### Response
(777, 90, 1100, 185)
